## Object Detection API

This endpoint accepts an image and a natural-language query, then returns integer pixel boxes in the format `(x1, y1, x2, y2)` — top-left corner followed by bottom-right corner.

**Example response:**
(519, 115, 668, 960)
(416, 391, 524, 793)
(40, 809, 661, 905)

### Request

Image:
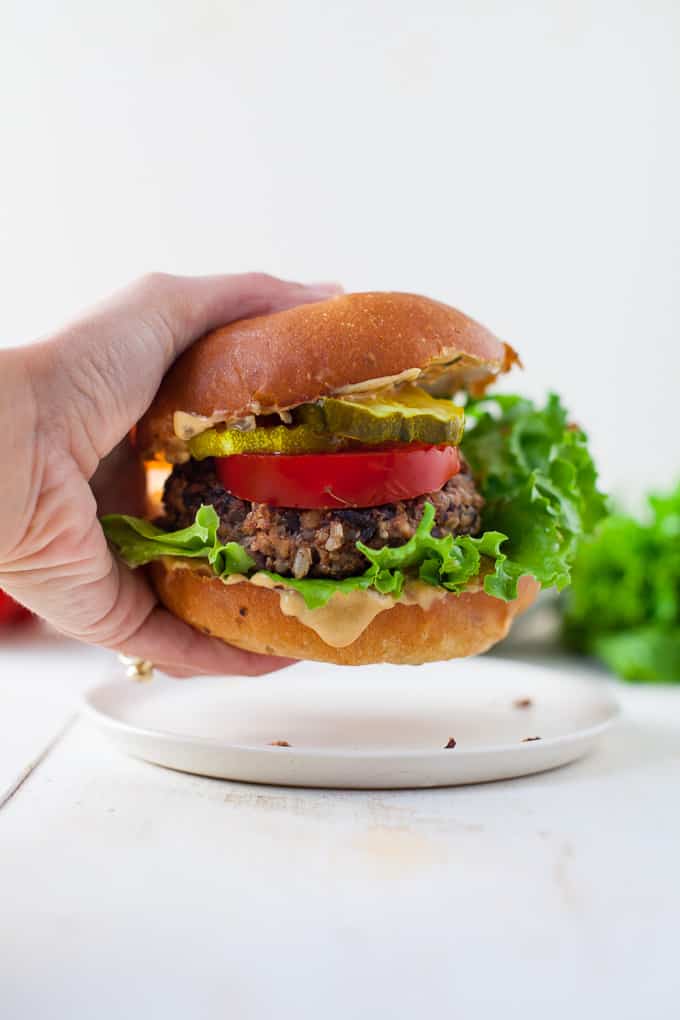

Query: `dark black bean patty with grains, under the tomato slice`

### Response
(158, 459, 484, 578)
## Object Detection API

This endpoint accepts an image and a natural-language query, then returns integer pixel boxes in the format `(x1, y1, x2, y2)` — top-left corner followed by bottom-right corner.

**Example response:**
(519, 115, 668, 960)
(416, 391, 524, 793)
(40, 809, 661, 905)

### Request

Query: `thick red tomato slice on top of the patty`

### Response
(215, 444, 461, 509)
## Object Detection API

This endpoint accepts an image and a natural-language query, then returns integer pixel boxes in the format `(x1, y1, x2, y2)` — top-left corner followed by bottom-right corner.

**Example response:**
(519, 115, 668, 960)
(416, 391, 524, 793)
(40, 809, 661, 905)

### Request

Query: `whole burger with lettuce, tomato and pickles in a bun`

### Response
(102, 293, 604, 665)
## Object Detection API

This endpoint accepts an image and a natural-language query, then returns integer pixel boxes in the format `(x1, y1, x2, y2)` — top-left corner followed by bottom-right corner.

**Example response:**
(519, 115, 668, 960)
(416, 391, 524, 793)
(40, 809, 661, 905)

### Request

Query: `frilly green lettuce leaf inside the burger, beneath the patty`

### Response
(102, 396, 605, 609)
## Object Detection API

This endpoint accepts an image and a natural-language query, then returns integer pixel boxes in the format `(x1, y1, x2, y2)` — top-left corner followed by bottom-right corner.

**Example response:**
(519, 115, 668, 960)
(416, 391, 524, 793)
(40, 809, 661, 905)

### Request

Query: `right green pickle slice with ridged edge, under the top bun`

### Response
(316, 386, 465, 446)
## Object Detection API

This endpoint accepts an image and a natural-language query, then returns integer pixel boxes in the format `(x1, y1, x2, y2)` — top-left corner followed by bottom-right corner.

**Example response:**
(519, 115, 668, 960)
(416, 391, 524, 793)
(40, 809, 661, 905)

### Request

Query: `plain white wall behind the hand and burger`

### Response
(0, 0, 680, 502)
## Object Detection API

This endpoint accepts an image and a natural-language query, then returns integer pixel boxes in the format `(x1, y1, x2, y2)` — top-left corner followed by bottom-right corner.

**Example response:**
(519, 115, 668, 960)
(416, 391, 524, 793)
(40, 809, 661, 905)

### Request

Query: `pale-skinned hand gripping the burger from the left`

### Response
(0, 273, 339, 676)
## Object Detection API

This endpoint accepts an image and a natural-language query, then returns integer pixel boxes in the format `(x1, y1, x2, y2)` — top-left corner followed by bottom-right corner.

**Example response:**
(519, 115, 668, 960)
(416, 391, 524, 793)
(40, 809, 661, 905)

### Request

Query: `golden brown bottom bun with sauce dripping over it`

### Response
(152, 560, 538, 666)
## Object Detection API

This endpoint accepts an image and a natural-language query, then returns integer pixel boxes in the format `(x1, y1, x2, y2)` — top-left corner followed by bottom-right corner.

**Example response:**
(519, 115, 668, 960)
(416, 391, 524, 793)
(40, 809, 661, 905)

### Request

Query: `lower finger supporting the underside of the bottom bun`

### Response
(115, 607, 295, 676)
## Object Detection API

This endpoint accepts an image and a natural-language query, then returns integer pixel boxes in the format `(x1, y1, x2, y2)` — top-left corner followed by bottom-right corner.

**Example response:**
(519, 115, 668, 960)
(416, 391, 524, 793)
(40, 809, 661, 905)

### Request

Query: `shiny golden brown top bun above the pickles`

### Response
(137, 292, 518, 459)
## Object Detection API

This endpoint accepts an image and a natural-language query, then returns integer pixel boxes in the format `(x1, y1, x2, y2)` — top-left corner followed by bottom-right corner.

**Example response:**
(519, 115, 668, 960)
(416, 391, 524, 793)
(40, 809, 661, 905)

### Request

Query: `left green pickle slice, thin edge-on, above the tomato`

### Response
(189, 425, 337, 460)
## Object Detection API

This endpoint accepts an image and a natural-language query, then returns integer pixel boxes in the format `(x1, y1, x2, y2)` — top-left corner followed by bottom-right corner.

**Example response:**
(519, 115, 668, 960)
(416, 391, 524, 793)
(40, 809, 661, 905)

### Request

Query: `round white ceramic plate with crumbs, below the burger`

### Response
(86, 658, 618, 788)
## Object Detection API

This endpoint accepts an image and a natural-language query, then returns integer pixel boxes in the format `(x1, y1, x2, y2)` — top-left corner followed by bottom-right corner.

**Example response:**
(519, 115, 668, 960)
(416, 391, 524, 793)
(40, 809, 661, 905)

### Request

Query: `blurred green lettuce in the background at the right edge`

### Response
(564, 483, 680, 682)
